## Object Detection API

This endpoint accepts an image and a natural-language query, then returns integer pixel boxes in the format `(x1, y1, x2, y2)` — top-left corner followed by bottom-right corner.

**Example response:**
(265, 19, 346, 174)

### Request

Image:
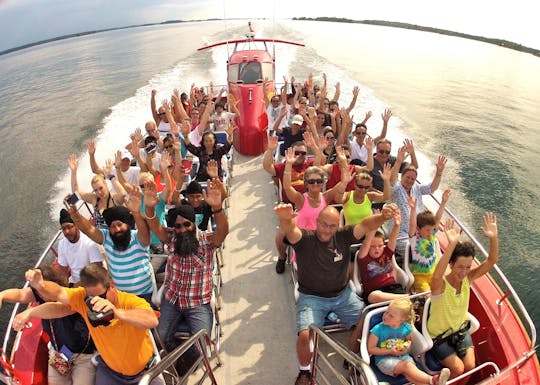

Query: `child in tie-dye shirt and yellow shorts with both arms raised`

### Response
(407, 190, 450, 293)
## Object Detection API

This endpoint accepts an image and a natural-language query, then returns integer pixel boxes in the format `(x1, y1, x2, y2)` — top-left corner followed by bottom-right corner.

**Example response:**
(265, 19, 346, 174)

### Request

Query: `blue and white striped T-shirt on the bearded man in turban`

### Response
(101, 229, 153, 295)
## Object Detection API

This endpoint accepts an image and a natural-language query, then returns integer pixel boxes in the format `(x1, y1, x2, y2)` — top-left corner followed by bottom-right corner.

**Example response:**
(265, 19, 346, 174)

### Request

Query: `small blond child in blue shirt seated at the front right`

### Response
(368, 298, 450, 385)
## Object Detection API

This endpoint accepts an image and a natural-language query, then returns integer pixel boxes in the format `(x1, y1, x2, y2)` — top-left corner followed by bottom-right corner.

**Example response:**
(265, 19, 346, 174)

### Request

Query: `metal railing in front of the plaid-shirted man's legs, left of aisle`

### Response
(139, 329, 217, 385)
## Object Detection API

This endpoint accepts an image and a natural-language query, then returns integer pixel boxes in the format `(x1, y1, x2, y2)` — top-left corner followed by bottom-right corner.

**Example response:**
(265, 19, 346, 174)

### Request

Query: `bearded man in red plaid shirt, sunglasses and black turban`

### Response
(144, 180, 229, 363)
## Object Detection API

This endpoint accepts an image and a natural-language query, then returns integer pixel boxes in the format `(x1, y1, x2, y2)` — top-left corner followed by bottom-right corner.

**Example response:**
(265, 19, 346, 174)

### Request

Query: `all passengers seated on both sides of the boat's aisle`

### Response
(0, 74, 498, 385)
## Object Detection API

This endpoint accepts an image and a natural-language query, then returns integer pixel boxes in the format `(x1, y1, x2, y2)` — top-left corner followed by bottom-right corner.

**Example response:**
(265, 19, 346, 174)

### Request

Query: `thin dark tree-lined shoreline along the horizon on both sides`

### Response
(0, 17, 540, 57)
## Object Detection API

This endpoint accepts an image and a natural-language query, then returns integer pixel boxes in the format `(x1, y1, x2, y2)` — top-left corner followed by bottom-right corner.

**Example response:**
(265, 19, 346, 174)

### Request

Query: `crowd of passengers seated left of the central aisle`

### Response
(0, 83, 238, 385)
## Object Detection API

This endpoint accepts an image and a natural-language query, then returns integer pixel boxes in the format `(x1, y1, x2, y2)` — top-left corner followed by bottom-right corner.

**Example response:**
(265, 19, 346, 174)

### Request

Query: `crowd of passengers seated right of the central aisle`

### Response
(263, 74, 498, 385)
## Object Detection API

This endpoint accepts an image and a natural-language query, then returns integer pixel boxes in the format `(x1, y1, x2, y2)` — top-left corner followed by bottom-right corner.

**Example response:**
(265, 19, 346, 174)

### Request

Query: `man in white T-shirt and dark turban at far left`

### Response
(58, 209, 103, 286)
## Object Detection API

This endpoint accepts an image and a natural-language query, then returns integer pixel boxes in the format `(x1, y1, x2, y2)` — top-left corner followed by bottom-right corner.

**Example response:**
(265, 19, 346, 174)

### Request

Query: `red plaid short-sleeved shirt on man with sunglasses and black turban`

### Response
(164, 230, 215, 309)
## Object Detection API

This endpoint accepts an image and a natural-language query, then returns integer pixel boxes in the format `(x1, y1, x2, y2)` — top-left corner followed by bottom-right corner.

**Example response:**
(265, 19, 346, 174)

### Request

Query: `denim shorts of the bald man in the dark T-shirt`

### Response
(296, 285, 364, 333)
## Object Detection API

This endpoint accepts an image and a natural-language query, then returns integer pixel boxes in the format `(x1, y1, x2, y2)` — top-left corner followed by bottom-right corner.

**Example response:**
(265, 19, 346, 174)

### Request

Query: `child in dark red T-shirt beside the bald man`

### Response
(357, 212, 405, 303)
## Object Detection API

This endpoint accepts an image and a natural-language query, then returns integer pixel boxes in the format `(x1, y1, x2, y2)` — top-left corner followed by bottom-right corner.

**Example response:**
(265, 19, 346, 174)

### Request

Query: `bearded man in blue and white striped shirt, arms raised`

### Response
(69, 191, 154, 302)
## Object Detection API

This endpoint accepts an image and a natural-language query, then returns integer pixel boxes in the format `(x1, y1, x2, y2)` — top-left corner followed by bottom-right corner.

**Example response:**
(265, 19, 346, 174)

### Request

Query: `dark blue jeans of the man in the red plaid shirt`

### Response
(158, 295, 214, 356)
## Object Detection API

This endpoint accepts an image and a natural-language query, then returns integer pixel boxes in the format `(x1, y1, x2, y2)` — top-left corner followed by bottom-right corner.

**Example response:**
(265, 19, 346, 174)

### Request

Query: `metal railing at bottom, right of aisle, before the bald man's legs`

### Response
(309, 324, 379, 385)
